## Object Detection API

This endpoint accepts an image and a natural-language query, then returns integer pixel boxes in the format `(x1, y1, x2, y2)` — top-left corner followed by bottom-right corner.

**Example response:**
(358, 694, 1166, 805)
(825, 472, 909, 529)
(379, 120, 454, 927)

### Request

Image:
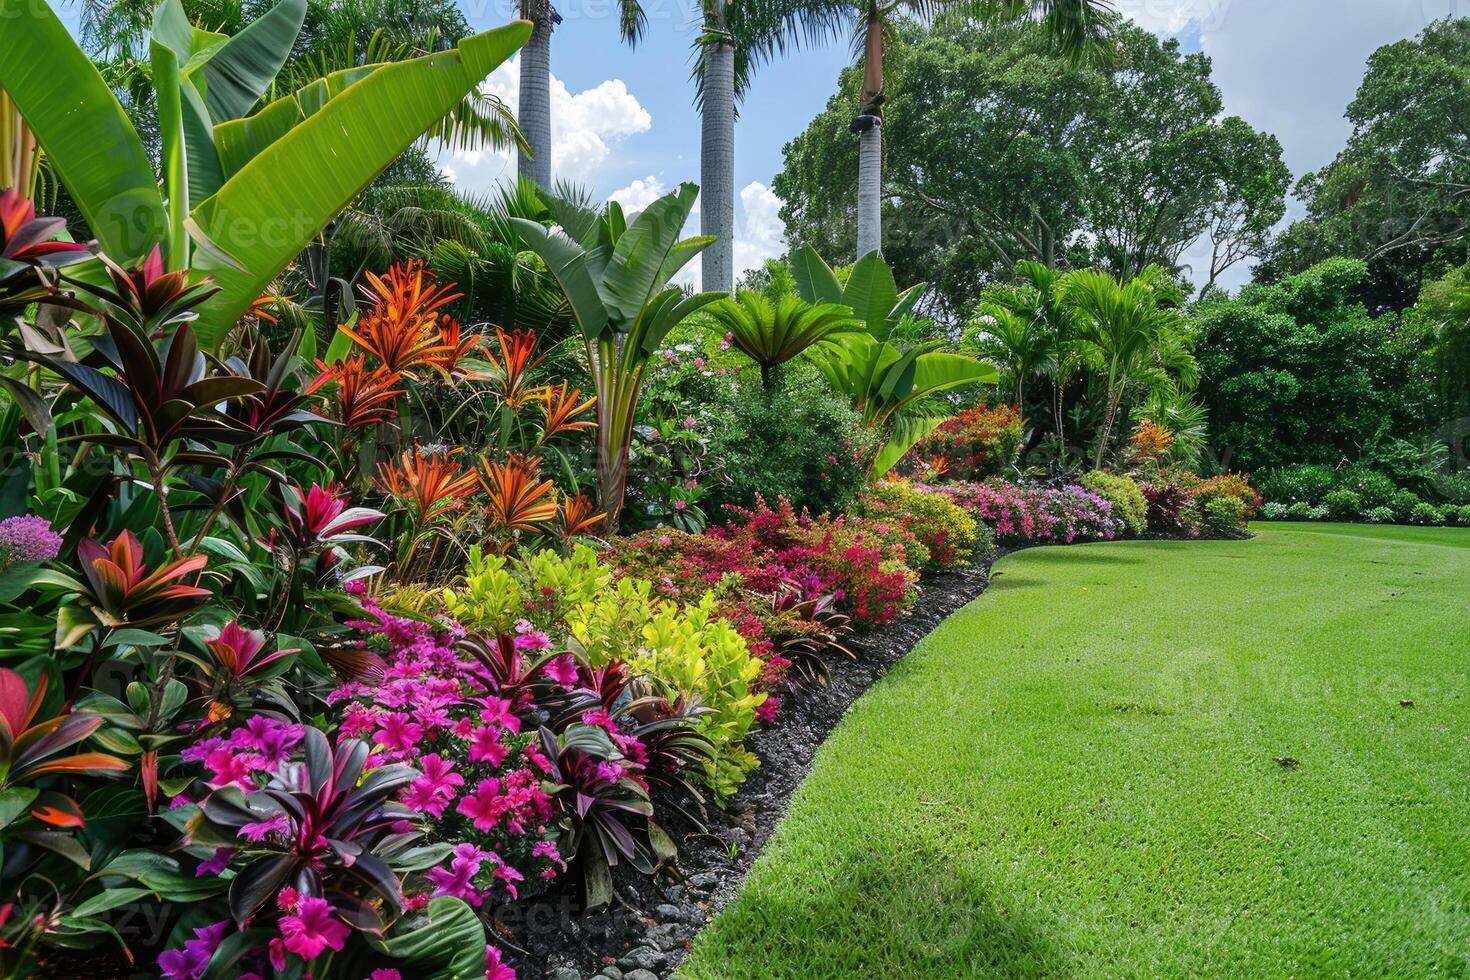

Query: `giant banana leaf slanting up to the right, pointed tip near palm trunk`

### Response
(193, 21, 531, 345)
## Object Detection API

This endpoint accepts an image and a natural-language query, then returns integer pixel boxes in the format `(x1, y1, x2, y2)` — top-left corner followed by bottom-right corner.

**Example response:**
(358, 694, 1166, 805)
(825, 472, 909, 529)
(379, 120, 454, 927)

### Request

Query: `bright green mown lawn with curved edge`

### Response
(684, 525, 1470, 980)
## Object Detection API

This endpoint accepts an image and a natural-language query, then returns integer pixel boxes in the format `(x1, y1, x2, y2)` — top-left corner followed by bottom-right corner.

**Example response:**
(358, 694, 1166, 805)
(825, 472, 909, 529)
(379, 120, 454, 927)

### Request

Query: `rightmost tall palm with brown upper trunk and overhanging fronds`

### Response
(851, 0, 1116, 259)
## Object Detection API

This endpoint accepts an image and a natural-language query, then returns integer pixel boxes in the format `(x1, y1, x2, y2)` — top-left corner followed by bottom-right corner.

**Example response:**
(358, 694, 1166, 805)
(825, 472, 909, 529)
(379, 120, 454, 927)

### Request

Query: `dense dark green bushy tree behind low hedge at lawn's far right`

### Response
(1194, 259, 1433, 470)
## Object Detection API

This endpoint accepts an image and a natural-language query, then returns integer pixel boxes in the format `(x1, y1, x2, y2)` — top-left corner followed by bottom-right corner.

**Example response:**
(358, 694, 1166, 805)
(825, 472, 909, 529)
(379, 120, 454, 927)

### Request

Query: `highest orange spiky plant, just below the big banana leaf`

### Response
(341, 260, 463, 373)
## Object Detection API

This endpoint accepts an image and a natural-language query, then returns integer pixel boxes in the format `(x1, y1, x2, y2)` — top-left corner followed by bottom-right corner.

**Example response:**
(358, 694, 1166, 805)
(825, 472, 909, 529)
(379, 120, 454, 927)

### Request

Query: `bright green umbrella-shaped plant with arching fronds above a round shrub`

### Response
(710, 289, 861, 391)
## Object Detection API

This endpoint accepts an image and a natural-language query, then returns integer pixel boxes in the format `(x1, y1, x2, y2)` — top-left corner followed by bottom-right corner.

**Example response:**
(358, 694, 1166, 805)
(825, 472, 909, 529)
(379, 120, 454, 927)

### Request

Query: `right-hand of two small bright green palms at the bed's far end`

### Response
(1058, 267, 1198, 467)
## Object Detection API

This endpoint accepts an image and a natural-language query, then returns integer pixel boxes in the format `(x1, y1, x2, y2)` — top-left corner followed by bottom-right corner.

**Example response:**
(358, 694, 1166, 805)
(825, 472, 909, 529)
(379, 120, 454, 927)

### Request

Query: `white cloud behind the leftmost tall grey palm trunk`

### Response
(440, 56, 653, 191)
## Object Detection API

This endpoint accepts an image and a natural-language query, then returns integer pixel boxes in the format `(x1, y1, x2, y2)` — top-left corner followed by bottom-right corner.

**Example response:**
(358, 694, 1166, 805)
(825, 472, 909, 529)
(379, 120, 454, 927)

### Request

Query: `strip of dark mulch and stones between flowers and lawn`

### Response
(495, 552, 1000, 980)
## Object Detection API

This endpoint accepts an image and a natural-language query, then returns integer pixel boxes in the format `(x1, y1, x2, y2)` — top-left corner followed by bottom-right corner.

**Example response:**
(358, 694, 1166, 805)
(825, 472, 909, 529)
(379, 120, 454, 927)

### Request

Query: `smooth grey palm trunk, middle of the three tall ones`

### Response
(700, 31, 735, 291)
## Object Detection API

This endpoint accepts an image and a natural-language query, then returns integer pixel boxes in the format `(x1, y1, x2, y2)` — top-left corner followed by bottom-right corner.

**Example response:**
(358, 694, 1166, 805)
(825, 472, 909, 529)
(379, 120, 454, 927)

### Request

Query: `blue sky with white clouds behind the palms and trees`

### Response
(53, 0, 1470, 285)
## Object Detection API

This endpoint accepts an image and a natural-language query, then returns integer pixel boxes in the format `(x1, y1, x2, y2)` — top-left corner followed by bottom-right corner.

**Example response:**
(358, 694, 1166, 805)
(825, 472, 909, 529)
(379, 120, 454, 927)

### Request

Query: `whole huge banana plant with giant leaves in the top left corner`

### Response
(0, 0, 531, 347)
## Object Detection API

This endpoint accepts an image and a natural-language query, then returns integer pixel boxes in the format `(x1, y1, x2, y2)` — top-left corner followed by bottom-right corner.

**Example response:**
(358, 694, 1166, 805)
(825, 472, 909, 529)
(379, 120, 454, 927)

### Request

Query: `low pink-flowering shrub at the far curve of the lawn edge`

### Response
(919, 480, 1125, 547)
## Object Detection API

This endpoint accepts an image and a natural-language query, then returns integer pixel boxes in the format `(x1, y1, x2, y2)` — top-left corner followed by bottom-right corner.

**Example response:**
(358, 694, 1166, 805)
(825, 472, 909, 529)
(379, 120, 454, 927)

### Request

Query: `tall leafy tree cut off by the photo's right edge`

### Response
(1255, 18, 1470, 310)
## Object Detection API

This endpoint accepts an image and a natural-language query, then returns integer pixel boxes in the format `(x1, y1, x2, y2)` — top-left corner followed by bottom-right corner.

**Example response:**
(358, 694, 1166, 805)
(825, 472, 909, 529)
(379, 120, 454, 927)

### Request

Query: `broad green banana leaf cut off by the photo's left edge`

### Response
(0, 0, 165, 263)
